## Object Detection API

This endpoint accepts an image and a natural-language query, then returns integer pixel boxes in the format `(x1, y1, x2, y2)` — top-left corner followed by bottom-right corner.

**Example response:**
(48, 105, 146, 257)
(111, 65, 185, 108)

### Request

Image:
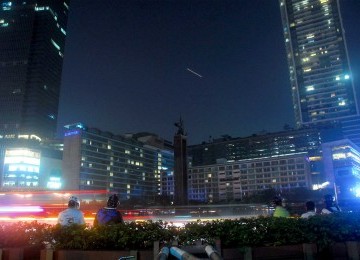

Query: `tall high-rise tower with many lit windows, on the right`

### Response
(279, 0, 360, 144)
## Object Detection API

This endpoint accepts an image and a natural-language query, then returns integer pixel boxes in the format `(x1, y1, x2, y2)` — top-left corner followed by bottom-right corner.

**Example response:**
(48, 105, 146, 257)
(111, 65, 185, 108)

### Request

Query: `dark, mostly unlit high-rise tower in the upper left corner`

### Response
(0, 0, 69, 138)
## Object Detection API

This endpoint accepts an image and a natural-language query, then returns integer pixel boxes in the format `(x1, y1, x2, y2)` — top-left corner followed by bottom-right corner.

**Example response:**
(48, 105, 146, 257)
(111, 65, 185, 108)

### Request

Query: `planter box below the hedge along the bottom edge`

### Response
(0, 241, 360, 260)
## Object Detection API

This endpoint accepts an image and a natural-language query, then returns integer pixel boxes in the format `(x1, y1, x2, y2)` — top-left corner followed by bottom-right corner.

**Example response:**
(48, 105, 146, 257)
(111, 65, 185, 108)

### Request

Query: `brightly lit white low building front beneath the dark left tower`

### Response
(0, 136, 62, 191)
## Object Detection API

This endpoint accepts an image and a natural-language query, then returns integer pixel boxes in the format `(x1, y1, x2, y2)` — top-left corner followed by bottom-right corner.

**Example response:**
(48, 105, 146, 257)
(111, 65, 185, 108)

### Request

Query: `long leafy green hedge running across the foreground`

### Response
(0, 213, 360, 250)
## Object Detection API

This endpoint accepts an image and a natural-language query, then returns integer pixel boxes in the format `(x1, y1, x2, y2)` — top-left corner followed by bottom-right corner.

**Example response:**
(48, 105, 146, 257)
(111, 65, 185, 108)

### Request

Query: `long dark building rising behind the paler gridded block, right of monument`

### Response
(188, 128, 343, 166)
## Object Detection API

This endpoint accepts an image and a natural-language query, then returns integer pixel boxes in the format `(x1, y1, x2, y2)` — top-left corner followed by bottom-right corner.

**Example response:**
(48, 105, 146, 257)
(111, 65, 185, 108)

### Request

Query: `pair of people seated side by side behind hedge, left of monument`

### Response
(58, 194, 124, 227)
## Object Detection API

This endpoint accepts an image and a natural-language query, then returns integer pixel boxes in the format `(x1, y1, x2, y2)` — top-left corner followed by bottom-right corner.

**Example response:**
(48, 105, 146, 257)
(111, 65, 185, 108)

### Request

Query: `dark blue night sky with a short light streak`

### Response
(58, 0, 360, 144)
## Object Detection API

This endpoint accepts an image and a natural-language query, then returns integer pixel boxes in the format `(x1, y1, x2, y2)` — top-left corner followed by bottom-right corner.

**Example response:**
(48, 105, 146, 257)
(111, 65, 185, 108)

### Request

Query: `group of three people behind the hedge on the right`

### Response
(272, 194, 341, 219)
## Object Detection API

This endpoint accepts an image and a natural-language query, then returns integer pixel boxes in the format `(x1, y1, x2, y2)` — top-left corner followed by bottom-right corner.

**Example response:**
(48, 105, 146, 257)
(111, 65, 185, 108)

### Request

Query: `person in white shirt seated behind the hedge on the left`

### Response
(58, 196, 85, 226)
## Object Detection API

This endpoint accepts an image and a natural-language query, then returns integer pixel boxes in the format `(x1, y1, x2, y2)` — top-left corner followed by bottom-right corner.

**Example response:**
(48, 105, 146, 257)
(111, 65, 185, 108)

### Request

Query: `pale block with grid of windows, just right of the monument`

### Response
(189, 153, 312, 203)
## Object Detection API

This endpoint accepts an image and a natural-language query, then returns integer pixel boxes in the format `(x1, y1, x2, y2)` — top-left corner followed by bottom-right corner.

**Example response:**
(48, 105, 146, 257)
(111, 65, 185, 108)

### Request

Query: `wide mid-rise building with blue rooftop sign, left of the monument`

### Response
(63, 124, 174, 202)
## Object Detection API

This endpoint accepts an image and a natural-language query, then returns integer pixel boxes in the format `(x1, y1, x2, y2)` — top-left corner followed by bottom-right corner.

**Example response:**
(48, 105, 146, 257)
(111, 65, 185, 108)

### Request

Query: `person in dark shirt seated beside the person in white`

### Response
(94, 194, 124, 227)
